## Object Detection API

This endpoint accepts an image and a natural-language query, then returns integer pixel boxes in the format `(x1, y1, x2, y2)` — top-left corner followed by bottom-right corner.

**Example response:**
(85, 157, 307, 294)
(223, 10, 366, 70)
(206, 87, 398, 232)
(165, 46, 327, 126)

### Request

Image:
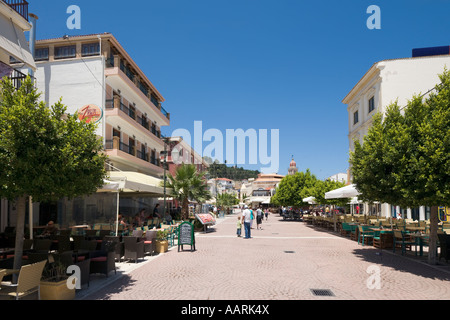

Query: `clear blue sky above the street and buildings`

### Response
(29, 0, 450, 179)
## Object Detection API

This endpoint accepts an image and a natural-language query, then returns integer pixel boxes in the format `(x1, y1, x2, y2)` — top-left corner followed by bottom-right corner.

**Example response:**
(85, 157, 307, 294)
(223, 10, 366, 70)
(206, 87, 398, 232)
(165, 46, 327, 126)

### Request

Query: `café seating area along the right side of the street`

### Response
(303, 215, 450, 262)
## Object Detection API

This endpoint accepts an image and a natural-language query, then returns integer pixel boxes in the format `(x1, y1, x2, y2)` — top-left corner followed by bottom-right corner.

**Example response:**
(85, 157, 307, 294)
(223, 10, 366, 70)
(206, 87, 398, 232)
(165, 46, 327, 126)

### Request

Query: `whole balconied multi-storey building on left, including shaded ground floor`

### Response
(11, 33, 170, 226)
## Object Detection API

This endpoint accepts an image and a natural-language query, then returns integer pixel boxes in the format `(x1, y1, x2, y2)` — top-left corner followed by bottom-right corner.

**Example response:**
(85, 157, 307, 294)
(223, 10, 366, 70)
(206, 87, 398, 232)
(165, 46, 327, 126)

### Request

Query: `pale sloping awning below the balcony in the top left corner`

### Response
(0, 15, 36, 70)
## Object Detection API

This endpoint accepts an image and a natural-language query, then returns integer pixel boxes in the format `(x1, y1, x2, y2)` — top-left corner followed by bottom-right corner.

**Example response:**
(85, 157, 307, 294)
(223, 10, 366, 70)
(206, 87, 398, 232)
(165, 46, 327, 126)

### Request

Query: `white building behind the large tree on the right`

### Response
(342, 47, 450, 220)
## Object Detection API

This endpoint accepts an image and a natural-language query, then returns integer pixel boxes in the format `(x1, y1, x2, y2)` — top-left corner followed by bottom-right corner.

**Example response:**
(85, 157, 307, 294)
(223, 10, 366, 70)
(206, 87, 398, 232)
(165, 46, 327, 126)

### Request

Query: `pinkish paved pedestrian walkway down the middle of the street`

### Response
(77, 215, 450, 301)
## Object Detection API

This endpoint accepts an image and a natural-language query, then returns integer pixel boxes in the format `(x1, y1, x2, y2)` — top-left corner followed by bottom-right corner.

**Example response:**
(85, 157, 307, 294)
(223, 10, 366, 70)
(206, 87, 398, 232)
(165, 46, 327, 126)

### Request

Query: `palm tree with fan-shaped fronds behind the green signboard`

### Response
(163, 163, 211, 220)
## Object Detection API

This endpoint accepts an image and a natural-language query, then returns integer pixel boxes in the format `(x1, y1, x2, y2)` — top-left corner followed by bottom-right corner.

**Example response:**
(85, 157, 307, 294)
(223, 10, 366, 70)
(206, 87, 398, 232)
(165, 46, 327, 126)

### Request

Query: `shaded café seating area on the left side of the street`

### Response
(0, 220, 183, 299)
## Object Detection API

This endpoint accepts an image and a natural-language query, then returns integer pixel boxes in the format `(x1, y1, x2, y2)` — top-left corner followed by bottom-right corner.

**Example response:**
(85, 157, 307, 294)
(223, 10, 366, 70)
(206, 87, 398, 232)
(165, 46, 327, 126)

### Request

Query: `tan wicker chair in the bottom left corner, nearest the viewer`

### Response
(0, 261, 47, 300)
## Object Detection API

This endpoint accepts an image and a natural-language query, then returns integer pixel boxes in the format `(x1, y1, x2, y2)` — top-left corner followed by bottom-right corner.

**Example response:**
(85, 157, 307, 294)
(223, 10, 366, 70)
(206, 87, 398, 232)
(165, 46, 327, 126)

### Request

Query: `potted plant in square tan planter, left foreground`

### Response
(40, 255, 75, 300)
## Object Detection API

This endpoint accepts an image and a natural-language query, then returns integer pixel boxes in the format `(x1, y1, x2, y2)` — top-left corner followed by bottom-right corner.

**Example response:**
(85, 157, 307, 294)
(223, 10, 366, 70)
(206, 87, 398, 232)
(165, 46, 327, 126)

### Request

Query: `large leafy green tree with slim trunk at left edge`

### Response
(0, 77, 106, 276)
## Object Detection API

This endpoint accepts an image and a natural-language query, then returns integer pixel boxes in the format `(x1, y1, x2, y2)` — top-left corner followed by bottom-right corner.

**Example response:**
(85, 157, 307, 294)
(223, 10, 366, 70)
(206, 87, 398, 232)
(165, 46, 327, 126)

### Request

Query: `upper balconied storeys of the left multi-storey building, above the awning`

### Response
(26, 33, 170, 177)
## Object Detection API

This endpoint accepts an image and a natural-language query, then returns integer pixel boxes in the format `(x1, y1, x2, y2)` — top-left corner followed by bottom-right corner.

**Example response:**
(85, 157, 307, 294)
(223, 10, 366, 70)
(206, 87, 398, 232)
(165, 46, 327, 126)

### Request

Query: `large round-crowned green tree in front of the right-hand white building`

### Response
(350, 70, 450, 264)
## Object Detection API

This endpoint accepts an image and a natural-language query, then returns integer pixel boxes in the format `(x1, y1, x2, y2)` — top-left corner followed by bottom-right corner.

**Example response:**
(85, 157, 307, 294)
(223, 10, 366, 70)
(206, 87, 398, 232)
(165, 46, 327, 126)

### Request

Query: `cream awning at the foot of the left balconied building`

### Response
(97, 171, 171, 197)
